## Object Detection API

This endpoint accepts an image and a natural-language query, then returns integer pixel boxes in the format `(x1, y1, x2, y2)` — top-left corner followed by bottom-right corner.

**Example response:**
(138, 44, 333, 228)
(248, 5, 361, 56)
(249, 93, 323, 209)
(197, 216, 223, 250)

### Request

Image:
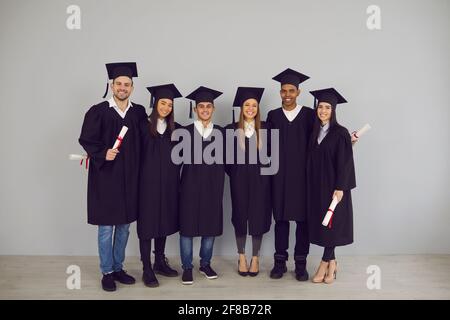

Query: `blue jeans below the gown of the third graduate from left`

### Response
(180, 235, 215, 270)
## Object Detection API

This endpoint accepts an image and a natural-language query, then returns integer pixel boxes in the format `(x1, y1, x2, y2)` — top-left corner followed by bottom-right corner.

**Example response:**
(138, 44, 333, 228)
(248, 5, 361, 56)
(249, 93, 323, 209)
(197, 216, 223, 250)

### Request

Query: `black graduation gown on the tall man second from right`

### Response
(267, 107, 314, 221)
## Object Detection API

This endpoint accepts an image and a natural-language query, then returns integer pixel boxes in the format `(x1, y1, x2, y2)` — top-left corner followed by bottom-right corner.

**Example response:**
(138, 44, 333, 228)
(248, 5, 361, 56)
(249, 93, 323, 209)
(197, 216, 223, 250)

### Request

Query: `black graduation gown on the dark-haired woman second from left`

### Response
(137, 120, 180, 240)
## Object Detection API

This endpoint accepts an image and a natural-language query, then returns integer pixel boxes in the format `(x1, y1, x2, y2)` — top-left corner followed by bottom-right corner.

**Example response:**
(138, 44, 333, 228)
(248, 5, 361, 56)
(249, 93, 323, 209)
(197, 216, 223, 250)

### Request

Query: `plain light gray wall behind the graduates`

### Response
(0, 0, 450, 255)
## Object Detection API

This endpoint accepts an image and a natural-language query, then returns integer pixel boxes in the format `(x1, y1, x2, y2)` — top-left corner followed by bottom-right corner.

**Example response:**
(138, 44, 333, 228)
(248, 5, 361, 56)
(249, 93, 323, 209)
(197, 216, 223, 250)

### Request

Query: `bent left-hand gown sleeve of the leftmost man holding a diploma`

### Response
(78, 107, 108, 169)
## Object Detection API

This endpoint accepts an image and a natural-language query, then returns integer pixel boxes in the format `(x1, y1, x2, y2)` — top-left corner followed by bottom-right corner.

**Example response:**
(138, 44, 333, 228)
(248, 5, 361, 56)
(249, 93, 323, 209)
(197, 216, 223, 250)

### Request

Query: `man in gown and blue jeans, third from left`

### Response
(179, 86, 225, 284)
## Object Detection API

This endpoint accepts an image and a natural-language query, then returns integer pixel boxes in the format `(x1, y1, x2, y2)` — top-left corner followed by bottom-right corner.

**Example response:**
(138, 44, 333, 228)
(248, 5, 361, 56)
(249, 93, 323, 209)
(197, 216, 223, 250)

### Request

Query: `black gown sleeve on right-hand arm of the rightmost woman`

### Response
(335, 130, 356, 190)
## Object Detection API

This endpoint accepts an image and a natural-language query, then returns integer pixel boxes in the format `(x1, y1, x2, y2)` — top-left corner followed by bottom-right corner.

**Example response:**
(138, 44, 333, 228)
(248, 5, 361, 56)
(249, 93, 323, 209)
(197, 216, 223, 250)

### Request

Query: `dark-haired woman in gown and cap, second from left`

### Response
(137, 84, 182, 287)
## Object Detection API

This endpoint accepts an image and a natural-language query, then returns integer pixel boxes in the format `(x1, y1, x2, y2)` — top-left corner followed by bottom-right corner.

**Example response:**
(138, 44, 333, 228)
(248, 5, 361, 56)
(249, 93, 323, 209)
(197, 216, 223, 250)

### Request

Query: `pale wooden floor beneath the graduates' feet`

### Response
(0, 255, 450, 300)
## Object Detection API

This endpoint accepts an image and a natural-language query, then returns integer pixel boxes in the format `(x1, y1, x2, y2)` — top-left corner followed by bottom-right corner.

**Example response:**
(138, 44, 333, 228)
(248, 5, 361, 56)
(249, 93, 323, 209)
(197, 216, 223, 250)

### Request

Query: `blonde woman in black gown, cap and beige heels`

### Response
(225, 87, 272, 276)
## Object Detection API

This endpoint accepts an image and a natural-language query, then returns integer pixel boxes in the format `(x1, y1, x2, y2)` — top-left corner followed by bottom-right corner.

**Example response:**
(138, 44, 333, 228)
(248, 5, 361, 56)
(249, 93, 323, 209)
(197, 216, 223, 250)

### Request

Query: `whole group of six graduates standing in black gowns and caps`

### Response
(79, 63, 357, 291)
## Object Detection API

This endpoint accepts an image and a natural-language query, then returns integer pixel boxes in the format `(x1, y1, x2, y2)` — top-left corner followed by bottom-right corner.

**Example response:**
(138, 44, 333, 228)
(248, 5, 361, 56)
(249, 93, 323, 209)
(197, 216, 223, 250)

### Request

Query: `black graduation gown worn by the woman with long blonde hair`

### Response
(225, 121, 272, 235)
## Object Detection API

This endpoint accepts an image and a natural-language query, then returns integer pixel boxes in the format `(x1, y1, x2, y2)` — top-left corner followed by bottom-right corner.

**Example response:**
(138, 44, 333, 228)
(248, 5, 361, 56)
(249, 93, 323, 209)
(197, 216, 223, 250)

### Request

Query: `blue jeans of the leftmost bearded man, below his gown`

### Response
(98, 224, 130, 274)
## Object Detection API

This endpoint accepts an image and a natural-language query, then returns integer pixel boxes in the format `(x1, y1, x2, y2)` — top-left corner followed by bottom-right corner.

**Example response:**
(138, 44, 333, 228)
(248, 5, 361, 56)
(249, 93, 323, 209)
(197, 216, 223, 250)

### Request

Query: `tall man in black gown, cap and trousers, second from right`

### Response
(267, 69, 314, 281)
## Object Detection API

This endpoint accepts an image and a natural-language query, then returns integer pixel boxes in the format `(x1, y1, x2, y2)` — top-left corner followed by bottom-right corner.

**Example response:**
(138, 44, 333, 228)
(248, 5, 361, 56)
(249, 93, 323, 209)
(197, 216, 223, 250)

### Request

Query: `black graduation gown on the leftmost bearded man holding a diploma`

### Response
(78, 101, 147, 225)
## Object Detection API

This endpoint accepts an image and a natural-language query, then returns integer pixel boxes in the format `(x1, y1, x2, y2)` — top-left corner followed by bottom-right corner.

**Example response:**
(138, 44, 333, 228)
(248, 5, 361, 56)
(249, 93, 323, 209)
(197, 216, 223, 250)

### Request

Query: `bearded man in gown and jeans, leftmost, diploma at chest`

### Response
(79, 62, 147, 291)
